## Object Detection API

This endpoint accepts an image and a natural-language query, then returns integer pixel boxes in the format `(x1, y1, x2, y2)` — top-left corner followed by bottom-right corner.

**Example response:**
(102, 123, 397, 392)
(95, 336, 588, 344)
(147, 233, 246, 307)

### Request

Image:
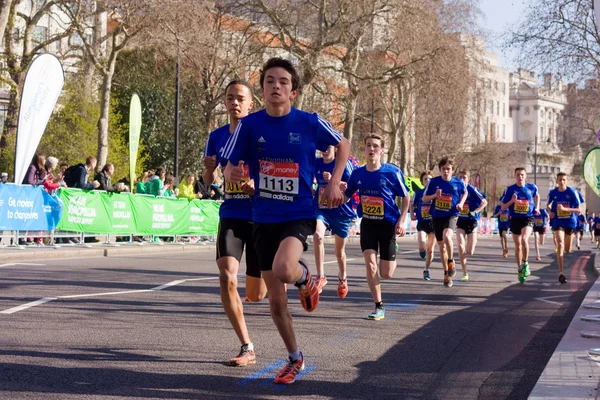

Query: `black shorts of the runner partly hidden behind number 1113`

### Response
(217, 218, 260, 278)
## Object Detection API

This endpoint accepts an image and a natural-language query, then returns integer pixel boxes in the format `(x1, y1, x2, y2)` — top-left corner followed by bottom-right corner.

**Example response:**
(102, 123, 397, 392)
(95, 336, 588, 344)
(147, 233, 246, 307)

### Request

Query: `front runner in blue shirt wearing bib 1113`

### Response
(222, 58, 350, 384)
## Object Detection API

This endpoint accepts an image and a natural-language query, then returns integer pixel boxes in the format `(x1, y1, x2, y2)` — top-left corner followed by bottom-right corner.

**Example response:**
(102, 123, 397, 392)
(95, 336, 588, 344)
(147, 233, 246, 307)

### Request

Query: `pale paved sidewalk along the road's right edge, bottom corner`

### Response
(528, 252, 600, 400)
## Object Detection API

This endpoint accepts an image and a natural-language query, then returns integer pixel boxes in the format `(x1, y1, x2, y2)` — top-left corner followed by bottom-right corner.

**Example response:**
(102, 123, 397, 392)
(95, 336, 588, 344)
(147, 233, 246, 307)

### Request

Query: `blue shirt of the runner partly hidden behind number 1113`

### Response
(204, 124, 252, 221)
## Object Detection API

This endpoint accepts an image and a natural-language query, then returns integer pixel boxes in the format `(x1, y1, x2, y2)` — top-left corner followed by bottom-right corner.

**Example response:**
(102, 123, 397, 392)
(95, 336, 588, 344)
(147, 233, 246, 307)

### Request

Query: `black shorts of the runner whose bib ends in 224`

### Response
(360, 218, 396, 261)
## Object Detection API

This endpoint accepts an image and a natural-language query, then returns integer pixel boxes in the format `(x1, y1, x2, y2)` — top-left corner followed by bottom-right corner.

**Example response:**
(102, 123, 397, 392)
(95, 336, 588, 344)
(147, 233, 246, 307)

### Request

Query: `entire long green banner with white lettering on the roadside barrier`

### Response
(57, 189, 220, 236)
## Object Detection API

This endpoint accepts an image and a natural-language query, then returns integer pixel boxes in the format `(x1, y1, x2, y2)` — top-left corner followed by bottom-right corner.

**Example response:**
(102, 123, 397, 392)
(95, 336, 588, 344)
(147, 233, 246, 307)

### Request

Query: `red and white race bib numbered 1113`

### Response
(258, 160, 300, 202)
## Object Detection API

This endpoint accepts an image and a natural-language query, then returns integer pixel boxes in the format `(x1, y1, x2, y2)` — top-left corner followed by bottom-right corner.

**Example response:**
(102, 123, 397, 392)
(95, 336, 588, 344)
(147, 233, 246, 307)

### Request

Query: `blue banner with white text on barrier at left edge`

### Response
(0, 184, 62, 231)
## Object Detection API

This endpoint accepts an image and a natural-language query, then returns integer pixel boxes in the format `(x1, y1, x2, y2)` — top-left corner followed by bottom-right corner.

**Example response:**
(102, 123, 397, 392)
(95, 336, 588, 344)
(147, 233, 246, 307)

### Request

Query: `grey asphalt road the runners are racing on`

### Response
(0, 234, 596, 400)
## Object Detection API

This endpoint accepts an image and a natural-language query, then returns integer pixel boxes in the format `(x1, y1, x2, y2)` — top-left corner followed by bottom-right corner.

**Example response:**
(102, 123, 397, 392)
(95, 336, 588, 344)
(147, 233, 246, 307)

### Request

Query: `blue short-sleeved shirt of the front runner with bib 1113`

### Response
(222, 107, 342, 223)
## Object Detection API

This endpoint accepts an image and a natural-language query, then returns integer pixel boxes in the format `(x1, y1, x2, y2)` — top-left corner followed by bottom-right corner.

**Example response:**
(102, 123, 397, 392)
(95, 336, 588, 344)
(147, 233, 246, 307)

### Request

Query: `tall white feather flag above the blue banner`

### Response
(15, 54, 65, 184)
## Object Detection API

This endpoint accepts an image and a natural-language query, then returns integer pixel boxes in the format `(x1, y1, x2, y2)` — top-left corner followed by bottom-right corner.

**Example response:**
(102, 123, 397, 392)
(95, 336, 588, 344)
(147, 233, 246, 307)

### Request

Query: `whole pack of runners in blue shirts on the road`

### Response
(203, 58, 600, 384)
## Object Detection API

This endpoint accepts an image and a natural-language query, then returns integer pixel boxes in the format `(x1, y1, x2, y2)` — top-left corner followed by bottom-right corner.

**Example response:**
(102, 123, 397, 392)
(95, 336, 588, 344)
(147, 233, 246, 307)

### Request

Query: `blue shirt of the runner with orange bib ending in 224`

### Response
(346, 163, 408, 225)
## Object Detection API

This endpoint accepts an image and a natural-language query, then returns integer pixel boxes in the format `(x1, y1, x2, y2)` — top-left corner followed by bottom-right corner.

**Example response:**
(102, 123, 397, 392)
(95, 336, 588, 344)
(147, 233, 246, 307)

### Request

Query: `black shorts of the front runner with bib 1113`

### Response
(253, 219, 317, 271)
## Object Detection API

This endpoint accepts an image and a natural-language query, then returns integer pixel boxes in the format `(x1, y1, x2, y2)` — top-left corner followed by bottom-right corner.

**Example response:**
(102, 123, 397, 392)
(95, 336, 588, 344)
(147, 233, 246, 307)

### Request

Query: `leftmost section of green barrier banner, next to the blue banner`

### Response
(56, 189, 111, 233)
